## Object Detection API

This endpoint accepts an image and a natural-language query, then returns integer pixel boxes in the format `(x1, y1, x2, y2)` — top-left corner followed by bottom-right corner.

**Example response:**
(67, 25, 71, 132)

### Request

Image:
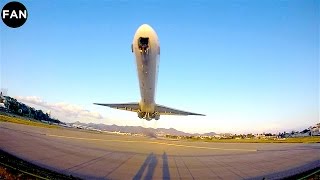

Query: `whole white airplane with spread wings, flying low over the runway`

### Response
(94, 24, 205, 121)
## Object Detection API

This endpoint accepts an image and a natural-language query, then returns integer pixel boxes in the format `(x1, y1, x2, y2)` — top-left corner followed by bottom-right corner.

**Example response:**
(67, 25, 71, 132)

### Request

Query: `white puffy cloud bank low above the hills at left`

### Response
(15, 96, 103, 119)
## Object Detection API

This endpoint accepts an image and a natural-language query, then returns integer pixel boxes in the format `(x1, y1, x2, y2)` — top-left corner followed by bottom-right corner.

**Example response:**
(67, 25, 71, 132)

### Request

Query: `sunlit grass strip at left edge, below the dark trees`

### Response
(0, 114, 59, 128)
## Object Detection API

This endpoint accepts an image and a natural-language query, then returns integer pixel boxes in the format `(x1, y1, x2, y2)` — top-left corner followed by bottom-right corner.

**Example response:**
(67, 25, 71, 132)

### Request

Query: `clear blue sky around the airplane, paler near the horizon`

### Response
(0, 0, 320, 133)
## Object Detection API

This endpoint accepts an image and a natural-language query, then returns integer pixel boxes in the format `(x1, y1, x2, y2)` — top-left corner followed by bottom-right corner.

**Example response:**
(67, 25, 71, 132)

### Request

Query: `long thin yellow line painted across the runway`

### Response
(47, 134, 257, 152)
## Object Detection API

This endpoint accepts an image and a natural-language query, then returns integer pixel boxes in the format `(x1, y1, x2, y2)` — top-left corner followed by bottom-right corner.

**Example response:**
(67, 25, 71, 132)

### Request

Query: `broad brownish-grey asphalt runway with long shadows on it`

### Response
(0, 122, 320, 179)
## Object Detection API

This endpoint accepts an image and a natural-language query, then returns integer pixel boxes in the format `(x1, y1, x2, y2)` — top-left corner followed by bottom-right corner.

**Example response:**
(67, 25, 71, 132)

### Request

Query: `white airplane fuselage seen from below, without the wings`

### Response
(132, 24, 160, 118)
